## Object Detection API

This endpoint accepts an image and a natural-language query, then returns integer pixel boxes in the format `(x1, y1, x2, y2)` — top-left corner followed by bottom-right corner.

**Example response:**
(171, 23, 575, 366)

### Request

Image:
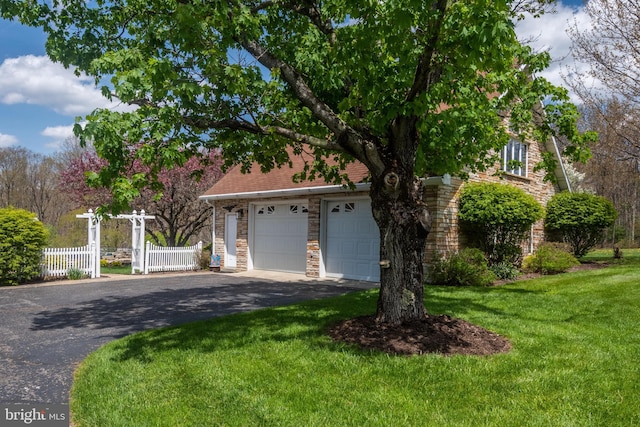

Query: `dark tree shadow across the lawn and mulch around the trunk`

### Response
(104, 291, 524, 362)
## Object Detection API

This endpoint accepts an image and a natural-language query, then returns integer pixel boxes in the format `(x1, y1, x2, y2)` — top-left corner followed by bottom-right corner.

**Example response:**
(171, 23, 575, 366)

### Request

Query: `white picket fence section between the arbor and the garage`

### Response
(144, 241, 202, 274)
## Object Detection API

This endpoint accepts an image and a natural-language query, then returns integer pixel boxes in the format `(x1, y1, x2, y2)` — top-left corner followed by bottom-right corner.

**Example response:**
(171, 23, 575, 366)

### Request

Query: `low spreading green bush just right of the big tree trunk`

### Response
(429, 248, 496, 286)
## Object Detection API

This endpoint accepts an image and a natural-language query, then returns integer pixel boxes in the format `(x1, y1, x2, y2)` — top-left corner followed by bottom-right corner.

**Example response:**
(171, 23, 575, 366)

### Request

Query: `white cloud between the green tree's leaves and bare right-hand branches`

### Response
(516, 3, 590, 103)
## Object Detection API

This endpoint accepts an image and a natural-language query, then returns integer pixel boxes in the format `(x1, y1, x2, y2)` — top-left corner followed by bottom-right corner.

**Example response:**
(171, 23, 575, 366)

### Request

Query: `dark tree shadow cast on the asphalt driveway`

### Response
(30, 281, 370, 338)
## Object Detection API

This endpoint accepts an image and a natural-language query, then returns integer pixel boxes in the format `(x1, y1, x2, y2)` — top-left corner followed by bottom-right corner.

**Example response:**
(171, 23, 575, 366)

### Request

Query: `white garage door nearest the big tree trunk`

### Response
(324, 199, 380, 281)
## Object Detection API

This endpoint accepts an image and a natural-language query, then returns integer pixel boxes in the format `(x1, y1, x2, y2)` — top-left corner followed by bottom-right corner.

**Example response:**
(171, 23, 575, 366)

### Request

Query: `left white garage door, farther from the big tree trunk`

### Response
(253, 203, 308, 273)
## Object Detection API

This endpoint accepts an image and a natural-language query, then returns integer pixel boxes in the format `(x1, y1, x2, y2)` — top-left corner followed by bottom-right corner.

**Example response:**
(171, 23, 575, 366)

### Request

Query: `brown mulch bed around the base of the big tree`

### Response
(329, 315, 511, 356)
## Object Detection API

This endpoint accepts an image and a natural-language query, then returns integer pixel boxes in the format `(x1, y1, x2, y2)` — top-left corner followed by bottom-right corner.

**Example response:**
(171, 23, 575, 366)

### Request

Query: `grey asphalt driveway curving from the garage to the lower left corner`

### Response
(0, 272, 376, 404)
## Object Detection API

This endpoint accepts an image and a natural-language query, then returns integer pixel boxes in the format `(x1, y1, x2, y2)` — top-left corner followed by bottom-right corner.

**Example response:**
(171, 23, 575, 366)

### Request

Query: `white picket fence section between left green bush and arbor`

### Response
(40, 243, 100, 278)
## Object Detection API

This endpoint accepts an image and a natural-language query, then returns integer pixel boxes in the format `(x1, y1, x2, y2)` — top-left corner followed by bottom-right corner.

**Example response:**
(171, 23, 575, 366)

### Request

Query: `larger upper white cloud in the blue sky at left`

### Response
(0, 55, 115, 116)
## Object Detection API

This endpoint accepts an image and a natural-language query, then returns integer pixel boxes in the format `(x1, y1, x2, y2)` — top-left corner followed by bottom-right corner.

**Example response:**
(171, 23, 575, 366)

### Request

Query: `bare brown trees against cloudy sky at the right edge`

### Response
(565, 0, 640, 246)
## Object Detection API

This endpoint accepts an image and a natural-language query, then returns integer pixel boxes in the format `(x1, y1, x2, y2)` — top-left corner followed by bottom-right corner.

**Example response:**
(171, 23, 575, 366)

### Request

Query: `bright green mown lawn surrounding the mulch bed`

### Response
(71, 254, 640, 426)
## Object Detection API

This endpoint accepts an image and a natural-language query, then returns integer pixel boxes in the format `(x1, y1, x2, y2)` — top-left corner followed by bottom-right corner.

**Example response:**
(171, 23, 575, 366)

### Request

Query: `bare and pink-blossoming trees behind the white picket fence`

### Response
(0, 139, 222, 248)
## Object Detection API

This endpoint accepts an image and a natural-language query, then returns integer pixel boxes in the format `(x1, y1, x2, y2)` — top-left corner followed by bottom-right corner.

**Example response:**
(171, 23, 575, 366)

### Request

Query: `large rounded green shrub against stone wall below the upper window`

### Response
(458, 183, 543, 265)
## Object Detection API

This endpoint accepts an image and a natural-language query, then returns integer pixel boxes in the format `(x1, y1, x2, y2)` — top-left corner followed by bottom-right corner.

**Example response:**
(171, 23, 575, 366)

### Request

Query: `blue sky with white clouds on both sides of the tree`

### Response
(0, 0, 586, 155)
